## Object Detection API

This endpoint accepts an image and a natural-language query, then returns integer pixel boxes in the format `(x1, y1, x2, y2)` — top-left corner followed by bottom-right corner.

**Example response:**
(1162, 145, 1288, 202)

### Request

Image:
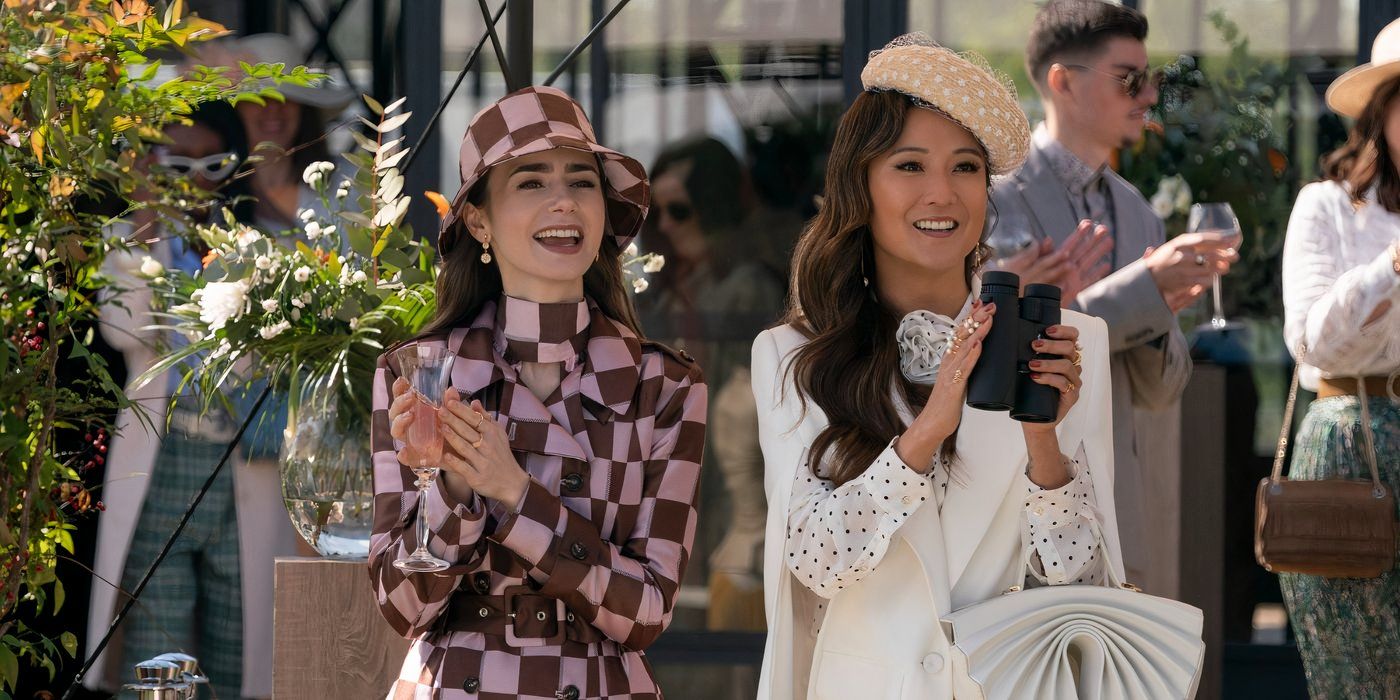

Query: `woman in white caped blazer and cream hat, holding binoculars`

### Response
(753, 36, 1121, 699)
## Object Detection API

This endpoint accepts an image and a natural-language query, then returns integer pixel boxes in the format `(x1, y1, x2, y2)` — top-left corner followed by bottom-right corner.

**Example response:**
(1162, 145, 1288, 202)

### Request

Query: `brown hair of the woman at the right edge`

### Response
(1322, 73, 1400, 213)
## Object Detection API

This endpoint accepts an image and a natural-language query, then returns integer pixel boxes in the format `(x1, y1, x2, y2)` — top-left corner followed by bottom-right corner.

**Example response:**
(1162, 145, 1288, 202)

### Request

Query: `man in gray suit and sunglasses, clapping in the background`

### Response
(991, 0, 1235, 592)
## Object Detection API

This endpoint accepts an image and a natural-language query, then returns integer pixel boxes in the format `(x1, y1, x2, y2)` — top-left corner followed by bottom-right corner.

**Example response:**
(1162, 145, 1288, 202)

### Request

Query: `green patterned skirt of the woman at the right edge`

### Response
(1278, 396, 1400, 700)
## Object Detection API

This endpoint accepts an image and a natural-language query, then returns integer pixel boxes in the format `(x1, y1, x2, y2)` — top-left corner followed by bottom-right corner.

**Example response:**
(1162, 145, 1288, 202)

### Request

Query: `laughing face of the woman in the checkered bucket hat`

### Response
(465, 148, 606, 302)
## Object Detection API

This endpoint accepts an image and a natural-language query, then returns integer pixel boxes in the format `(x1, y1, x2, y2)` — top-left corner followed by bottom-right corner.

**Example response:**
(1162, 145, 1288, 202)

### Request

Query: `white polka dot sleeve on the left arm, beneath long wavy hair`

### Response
(784, 441, 932, 598)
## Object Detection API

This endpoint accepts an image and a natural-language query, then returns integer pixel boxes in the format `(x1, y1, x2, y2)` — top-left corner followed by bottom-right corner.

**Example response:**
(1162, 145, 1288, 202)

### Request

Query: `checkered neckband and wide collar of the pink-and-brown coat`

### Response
(452, 295, 641, 413)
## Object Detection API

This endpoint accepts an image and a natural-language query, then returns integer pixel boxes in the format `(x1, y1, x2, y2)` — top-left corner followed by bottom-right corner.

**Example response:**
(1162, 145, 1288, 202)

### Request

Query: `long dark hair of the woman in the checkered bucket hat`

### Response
(420, 172, 647, 339)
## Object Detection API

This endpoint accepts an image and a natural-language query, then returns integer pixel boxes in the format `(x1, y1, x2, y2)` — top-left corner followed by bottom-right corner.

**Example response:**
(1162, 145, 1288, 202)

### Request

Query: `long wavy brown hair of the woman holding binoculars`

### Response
(783, 92, 987, 484)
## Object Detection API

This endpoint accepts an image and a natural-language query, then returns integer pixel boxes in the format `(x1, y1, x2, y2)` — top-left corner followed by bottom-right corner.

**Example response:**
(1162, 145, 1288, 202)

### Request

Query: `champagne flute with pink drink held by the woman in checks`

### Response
(393, 344, 454, 573)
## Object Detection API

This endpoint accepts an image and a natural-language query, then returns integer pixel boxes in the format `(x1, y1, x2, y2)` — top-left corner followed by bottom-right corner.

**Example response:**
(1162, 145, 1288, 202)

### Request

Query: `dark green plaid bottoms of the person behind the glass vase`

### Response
(118, 431, 244, 700)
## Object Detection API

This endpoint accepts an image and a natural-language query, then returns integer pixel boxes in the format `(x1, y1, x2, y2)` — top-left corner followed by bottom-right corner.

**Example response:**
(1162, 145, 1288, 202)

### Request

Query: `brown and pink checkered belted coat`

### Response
(370, 297, 707, 700)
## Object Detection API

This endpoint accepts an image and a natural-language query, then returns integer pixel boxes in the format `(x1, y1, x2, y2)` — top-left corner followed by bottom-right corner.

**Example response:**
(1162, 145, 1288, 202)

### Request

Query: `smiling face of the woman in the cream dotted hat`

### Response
(868, 108, 987, 294)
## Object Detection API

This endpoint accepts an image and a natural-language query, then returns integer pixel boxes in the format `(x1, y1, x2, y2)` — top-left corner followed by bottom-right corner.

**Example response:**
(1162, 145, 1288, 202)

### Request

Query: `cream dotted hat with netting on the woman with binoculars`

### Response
(861, 32, 1030, 175)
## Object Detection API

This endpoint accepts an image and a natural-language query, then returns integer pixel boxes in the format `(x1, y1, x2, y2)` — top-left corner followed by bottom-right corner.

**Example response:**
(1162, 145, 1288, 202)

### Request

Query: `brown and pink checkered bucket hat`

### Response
(438, 85, 651, 258)
